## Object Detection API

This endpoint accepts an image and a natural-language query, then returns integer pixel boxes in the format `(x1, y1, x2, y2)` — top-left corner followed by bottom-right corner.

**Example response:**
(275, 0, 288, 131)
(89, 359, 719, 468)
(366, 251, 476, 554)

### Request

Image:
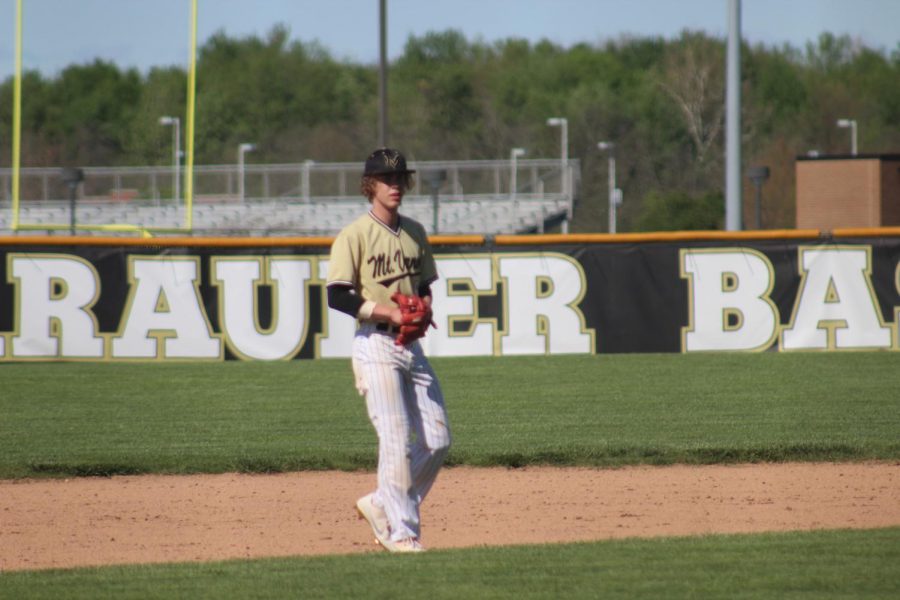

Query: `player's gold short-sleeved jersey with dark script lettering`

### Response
(327, 212, 438, 305)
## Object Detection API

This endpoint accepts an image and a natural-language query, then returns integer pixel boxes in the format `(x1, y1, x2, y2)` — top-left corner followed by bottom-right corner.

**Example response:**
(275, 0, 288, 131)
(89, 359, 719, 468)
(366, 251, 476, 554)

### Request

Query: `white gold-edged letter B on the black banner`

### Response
(679, 248, 779, 352)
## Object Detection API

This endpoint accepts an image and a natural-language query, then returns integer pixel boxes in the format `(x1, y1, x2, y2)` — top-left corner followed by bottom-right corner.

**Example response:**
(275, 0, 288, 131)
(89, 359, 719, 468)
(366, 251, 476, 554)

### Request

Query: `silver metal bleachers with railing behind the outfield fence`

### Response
(0, 159, 577, 236)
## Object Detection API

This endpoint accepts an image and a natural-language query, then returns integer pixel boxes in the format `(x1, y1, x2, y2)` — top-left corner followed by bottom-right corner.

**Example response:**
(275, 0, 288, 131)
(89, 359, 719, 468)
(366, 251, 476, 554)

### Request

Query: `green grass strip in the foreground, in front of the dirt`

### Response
(0, 528, 900, 600)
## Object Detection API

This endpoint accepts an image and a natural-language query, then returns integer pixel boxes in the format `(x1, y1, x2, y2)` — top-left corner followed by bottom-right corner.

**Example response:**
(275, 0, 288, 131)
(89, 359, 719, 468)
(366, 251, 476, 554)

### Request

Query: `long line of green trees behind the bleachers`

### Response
(0, 26, 900, 231)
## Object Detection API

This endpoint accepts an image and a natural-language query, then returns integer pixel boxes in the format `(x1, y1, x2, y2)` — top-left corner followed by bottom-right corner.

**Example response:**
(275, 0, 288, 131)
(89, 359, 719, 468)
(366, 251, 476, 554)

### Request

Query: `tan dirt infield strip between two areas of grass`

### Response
(0, 463, 900, 571)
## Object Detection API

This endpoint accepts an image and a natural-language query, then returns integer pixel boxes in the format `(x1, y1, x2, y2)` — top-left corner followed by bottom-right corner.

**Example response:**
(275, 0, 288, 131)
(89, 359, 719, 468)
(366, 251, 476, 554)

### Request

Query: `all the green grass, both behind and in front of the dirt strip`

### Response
(0, 353, 900, 598)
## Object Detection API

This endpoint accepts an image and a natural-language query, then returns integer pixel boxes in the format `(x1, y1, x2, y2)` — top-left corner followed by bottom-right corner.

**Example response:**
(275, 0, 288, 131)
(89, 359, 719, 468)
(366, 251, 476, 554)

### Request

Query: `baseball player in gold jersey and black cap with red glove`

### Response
(327, 148, 450, 552)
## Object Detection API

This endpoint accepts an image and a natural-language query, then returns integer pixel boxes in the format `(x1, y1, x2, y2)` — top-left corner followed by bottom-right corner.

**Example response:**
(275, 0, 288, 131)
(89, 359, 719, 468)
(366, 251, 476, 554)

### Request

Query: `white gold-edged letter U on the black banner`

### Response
(209, 256, 312, 360)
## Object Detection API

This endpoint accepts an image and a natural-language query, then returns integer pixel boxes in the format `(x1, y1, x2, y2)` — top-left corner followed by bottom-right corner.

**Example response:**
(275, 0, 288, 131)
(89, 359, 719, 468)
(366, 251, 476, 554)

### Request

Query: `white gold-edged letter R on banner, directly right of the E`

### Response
(496, 254, 594, 355)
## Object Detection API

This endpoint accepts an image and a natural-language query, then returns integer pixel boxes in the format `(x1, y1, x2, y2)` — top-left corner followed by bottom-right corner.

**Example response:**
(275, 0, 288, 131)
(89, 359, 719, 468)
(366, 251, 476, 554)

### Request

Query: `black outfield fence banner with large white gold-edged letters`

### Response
(0, 236, 900, 361)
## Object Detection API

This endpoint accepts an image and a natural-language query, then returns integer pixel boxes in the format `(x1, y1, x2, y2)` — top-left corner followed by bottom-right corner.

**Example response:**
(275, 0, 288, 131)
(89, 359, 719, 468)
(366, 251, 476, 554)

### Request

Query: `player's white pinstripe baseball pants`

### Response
(353, 323, 450, 540)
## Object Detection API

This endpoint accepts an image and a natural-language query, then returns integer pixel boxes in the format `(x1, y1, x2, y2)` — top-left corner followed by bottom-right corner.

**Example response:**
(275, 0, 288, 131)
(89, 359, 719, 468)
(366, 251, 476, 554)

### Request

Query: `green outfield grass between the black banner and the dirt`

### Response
(0, 353, 900, 478)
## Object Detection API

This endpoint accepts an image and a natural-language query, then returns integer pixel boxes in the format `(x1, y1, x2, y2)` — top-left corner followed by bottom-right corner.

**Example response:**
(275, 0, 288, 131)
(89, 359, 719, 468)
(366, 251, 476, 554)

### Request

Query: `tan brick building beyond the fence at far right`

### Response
(796, 154, 900, 230)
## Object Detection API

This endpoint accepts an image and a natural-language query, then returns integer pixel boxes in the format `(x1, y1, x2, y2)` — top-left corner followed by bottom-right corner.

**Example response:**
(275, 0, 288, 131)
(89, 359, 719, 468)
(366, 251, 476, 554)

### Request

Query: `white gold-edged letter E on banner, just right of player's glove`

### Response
(422, 254, 498, 356)
